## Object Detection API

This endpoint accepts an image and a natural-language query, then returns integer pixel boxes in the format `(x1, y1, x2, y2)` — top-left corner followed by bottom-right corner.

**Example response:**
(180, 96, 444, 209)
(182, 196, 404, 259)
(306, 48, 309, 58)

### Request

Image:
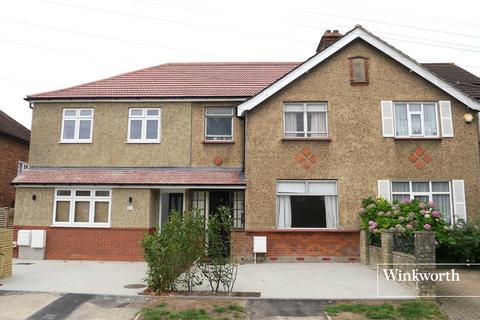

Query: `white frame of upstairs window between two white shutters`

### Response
(393, 101, 440, 138)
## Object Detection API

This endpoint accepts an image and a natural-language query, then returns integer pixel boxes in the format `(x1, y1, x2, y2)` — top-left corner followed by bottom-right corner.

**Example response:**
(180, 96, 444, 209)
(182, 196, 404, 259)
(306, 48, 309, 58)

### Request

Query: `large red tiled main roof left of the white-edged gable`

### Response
(27, 62, 299, 100)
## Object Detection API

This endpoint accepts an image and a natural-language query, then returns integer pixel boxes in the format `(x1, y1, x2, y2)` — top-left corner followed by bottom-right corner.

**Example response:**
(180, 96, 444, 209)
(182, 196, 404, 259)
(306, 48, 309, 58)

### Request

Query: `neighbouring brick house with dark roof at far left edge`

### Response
(0, 110, 30, 208)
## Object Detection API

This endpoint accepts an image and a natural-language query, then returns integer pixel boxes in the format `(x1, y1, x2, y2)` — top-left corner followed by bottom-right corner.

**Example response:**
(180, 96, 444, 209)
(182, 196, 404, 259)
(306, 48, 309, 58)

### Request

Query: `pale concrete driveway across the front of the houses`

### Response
(0, 260, 410, 299)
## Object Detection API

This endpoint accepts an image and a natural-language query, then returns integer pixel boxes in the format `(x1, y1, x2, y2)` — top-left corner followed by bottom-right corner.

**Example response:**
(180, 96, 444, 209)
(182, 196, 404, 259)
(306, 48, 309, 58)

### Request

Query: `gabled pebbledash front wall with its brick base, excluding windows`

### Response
(233, 41, 480, 260)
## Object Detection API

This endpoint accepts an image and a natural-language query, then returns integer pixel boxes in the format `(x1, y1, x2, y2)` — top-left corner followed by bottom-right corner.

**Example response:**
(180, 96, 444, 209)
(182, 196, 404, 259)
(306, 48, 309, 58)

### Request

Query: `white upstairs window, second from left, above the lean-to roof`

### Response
(127, 108, 162, 143)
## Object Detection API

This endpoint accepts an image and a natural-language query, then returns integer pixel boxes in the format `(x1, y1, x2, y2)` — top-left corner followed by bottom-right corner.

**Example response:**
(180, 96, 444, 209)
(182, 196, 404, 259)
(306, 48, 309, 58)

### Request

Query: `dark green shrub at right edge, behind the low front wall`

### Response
(437, 220, 480, 263)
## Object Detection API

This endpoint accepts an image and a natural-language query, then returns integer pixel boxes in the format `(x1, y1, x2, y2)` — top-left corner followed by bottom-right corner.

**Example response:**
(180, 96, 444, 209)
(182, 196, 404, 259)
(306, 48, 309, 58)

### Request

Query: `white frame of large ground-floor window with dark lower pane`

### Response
(275, 179, 340, 230)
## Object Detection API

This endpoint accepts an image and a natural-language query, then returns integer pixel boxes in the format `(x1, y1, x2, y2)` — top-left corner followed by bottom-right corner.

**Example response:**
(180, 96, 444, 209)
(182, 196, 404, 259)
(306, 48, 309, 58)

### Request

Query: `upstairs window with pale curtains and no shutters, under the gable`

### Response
(283, 102, 328, 138)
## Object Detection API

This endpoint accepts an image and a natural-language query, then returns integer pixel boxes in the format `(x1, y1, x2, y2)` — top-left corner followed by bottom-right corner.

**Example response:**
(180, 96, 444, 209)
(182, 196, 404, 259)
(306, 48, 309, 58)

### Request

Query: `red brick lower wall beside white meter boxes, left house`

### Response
(14, 226, 149, 261)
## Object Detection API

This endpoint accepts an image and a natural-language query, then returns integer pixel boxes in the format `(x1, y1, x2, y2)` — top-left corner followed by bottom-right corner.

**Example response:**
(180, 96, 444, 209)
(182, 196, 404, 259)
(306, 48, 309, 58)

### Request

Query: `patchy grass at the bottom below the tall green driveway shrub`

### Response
(142, 303, 244, 320)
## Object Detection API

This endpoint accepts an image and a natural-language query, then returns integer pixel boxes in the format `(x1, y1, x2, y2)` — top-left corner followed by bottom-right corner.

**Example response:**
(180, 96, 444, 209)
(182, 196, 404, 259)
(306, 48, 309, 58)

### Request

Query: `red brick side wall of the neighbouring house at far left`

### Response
(0, 134, 29, 207)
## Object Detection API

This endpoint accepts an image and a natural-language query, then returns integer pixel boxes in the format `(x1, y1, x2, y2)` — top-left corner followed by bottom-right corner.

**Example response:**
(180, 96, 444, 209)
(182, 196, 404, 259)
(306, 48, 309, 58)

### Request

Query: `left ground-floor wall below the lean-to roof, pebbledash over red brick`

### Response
(14, 188, 158, 261)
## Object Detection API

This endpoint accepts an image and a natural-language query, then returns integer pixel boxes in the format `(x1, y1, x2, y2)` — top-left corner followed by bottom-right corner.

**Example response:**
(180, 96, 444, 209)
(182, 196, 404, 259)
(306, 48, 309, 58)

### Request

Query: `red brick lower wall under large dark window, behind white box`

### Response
(232, 230, 360, 261)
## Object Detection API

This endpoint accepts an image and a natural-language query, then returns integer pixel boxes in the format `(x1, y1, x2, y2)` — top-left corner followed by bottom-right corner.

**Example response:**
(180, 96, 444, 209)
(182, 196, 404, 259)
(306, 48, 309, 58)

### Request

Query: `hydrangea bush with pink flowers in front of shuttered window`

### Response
(359, 197, 448, 242)
